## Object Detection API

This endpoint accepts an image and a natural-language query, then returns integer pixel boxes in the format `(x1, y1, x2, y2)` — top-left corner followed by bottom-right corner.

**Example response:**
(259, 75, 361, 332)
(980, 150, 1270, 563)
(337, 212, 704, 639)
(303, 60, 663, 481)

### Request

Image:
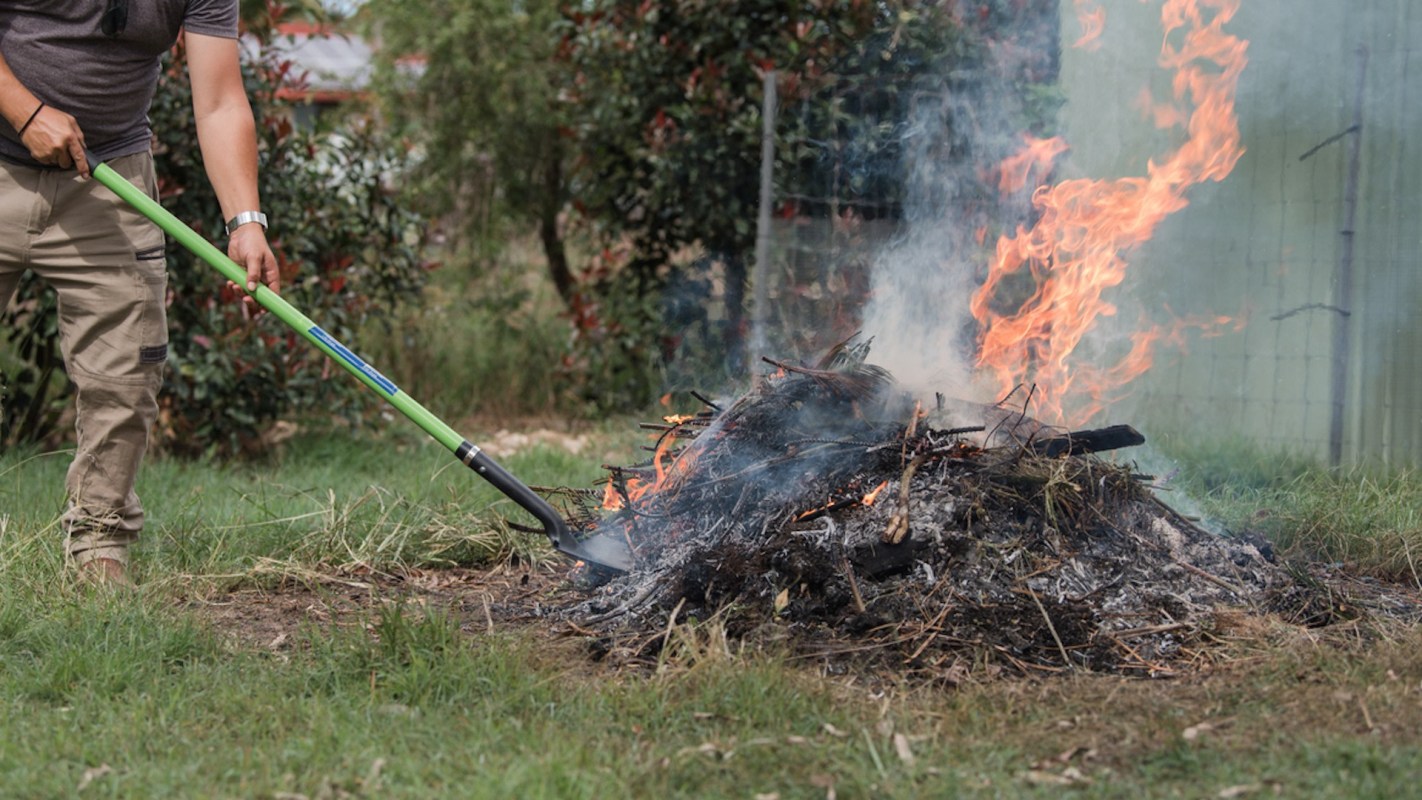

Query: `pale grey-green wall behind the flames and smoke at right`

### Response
(1058, 0, 1422, 463)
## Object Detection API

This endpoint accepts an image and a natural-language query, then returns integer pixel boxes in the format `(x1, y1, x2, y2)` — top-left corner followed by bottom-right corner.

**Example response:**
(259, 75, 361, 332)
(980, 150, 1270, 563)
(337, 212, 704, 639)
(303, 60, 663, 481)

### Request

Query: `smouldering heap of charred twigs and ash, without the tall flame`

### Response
(566, 345, 1342, 674)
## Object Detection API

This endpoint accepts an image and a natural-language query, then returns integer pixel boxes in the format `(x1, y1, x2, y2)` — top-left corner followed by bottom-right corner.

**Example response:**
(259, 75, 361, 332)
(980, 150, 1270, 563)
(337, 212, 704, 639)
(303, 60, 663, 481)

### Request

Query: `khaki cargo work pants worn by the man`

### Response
(0, 153, 168, 564)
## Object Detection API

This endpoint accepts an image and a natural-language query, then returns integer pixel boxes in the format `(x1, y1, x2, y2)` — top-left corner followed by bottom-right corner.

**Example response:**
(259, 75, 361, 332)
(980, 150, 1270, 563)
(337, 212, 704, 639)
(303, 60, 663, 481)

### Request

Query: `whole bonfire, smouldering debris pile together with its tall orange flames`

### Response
(534, 0, 1416, 679)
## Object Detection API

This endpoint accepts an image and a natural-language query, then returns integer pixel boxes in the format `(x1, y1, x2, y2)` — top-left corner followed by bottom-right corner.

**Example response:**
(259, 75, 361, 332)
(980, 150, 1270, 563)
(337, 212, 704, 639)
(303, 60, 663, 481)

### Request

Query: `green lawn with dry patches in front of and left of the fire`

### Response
(0, 433, 1422, 800)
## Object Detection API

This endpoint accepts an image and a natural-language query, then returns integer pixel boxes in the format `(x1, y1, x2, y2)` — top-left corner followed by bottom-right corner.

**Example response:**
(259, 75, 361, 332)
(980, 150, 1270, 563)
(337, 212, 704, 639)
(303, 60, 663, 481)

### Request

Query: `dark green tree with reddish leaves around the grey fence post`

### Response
(562, 0, 958, 375)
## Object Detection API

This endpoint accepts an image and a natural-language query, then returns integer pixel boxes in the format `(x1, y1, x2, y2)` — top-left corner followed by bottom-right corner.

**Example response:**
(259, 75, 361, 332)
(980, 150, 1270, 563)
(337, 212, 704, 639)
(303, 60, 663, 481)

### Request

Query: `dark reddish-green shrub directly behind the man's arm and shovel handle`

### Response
(151, 40, 424, 455)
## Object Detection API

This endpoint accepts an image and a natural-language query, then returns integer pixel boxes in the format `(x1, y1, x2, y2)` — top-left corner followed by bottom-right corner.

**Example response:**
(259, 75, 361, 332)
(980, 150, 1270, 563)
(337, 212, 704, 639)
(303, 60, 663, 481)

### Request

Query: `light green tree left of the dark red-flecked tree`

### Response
(361, 0, 574, 301)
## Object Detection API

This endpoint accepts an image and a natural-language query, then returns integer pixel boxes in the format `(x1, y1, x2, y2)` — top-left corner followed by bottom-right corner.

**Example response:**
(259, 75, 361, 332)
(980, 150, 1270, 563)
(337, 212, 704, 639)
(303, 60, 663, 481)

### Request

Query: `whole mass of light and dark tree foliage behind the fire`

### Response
(363, 0, 1055, 417)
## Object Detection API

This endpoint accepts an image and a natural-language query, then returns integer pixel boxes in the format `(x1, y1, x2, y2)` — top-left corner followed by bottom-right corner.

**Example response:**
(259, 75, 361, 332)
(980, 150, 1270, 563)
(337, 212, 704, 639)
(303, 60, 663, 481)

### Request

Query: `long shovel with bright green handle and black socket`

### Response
(84, 152, 631, 573)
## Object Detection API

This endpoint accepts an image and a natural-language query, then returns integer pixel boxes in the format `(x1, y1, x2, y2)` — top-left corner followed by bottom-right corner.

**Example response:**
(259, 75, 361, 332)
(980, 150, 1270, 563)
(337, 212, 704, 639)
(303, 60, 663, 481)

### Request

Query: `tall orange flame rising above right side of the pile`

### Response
(971, 0, 1249, 423)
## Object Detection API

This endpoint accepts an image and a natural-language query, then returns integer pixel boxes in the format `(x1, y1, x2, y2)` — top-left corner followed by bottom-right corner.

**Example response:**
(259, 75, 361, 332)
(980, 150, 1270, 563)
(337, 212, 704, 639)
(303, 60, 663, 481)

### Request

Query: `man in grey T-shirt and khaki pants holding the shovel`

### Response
(0, 0, 277, 584)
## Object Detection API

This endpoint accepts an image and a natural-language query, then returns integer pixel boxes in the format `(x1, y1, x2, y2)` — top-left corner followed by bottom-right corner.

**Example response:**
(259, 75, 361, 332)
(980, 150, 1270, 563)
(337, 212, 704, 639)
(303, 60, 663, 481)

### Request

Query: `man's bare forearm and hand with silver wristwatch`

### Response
(183, 33, 280, 311)
